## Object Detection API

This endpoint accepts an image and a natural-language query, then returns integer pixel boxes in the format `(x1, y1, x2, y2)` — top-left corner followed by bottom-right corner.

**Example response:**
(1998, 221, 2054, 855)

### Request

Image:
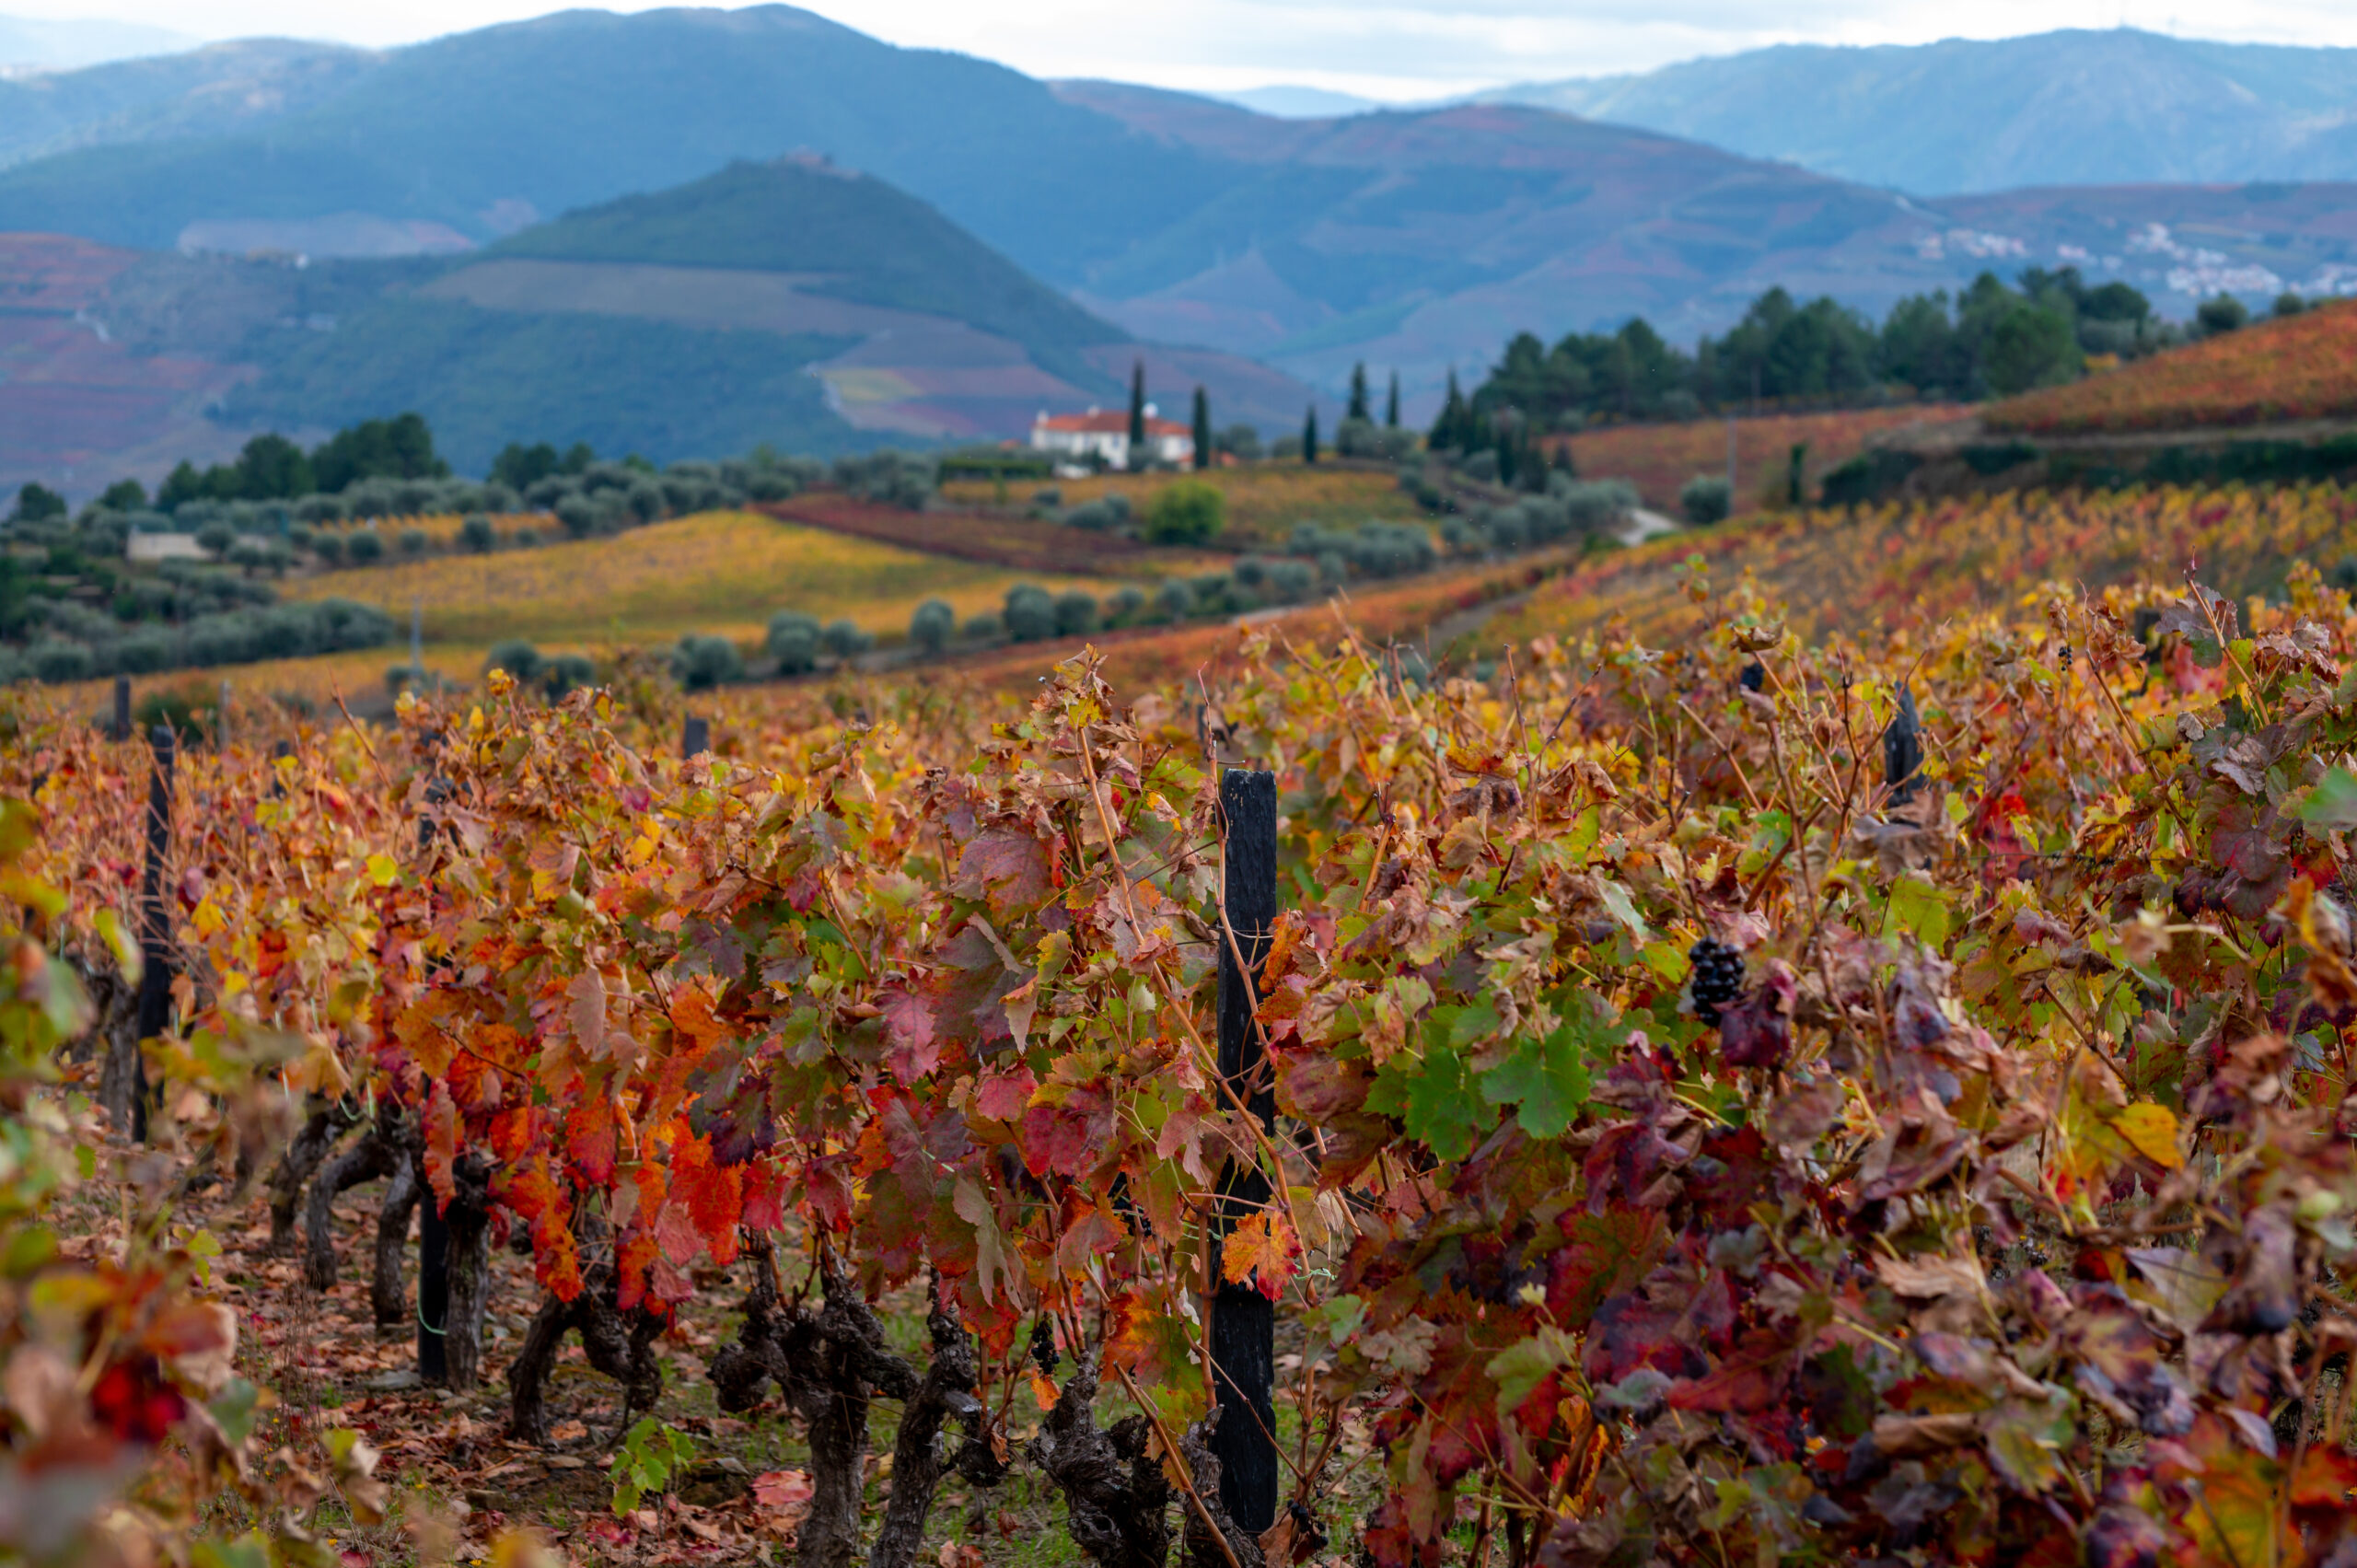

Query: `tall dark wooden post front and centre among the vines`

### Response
(1212, 769, 1278, 1538)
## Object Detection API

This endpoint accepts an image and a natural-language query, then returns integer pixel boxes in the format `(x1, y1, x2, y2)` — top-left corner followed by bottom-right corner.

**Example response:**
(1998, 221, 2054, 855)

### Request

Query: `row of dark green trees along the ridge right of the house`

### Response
(1431, 266, 2305, 431)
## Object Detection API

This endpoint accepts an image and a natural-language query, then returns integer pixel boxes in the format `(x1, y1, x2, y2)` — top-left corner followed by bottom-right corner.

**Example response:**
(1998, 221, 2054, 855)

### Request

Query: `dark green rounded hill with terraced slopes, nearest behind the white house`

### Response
(0, 158, 1310, 493)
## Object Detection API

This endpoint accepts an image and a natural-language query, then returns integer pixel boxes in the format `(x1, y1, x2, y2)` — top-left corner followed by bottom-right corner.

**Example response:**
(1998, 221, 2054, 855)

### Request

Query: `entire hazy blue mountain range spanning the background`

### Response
(0, 5, 2357, 490)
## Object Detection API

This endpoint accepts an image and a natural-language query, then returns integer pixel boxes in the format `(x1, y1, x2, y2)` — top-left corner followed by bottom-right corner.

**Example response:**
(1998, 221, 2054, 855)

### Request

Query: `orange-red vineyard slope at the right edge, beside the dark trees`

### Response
(1982, 304, 2357, 436)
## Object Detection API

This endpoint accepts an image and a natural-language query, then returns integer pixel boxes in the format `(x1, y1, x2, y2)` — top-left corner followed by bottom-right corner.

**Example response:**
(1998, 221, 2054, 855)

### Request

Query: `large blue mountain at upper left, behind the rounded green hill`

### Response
(0, 5, 1224, 285)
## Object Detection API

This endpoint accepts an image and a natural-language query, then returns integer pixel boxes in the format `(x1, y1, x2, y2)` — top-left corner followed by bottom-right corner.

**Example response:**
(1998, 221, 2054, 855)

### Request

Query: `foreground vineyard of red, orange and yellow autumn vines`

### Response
(14, 488, 2357, 1568)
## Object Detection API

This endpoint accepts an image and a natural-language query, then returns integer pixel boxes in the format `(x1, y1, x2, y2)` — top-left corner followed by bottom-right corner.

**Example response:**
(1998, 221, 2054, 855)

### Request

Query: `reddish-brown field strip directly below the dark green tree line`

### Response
(1550, 403, 1970, 517)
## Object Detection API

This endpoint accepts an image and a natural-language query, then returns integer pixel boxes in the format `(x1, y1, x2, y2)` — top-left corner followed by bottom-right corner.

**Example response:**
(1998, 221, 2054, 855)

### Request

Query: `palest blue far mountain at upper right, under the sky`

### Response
(1473, 29, 2357, 196)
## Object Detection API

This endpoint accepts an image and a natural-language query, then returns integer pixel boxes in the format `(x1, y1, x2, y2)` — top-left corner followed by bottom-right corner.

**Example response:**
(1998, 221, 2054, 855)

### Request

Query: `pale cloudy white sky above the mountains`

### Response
(14, 0, 2357, 101)
